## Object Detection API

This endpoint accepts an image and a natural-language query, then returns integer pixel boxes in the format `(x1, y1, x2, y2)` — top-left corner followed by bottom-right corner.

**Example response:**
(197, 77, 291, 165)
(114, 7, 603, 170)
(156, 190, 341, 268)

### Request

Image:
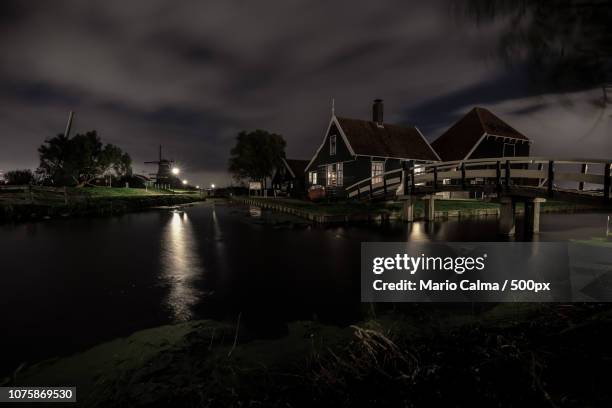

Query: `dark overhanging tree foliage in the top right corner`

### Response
(456, 0, 612, 90)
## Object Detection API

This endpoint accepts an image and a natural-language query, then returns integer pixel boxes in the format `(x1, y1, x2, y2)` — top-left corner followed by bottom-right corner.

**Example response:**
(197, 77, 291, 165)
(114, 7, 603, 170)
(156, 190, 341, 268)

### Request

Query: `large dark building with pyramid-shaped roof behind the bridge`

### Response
(431, 107, 531, 161)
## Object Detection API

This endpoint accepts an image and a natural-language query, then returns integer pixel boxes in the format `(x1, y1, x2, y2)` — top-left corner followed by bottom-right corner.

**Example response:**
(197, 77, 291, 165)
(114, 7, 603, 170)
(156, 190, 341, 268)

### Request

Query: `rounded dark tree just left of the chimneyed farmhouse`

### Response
(229, 129, 287, 188)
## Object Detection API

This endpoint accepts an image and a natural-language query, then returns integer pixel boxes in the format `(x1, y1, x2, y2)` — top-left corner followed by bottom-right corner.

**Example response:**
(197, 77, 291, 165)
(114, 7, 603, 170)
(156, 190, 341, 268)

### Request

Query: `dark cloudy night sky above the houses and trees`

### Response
(0, 0, 612, 185)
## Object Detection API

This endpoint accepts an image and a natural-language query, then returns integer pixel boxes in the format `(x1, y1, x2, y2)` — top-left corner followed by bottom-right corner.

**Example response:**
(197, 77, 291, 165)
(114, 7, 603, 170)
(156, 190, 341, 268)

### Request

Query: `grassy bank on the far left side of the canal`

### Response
(0, 187, 204, 223)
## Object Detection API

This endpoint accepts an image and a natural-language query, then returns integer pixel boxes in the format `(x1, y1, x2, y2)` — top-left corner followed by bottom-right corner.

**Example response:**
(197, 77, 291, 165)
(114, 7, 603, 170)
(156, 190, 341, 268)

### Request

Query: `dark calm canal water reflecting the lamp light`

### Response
(0, 203, 607, 377)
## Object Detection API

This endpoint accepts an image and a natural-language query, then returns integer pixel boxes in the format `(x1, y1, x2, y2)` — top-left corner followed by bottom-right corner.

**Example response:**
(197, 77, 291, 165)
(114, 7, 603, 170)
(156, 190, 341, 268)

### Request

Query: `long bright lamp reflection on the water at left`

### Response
(161, 212, 203, 321)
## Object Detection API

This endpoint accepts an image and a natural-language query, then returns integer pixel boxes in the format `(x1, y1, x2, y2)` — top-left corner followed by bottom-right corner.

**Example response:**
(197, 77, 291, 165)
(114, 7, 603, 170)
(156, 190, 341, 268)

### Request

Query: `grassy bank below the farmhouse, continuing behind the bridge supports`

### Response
(232, 196, 595, 224)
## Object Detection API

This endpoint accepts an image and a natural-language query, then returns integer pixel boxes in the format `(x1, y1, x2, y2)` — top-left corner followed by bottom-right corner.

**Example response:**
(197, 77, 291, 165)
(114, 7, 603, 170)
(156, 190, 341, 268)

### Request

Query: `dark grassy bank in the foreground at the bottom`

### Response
(4, 304, 612, 407)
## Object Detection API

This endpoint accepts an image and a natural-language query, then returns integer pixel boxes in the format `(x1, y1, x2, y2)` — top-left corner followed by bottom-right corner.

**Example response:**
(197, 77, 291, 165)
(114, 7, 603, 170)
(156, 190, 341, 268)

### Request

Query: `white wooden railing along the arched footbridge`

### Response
(347, 157, 612, 203)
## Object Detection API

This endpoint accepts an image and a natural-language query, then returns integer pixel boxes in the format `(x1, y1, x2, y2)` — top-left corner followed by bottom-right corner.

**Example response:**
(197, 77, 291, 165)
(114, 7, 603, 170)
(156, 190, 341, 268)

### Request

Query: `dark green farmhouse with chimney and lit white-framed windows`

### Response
(305, 99, 440, 197)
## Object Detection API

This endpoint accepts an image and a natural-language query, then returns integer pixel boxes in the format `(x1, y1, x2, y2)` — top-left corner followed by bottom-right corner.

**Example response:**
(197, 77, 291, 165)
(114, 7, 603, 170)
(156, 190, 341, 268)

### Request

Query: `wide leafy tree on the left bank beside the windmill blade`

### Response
(37, 130, 132, 187)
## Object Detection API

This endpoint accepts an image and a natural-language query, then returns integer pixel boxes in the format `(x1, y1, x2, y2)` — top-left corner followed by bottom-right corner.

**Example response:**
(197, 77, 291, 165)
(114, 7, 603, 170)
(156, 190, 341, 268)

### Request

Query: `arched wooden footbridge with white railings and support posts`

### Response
(346, 157, 612, 234)
